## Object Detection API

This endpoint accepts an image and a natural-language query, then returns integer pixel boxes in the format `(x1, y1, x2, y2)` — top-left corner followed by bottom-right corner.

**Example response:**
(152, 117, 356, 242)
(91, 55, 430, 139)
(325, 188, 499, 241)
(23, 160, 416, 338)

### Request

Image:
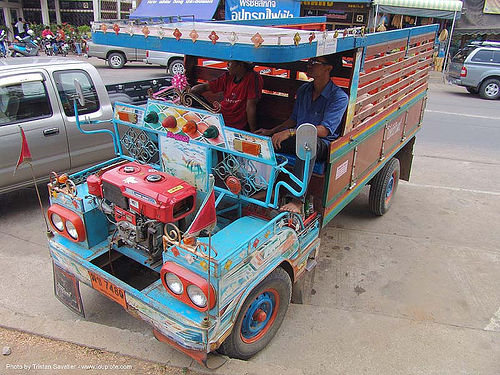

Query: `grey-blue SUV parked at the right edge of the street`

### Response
(447, 41, 500, 99)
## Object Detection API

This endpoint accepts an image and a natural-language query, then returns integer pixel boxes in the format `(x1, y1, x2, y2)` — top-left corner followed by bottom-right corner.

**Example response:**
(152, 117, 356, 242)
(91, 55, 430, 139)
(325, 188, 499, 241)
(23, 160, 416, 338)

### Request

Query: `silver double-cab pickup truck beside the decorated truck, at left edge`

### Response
(0, 57, 170, 194)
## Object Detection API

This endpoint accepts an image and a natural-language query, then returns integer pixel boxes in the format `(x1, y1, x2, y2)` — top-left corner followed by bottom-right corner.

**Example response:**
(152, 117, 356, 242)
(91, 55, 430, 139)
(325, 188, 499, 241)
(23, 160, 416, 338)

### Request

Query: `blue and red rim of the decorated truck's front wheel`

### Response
(241, 290, 279, 343)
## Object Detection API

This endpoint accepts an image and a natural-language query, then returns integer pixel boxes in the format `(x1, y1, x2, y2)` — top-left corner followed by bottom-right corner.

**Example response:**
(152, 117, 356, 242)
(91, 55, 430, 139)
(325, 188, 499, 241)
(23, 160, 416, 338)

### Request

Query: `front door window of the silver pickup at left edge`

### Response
(0, 81, 52, 126)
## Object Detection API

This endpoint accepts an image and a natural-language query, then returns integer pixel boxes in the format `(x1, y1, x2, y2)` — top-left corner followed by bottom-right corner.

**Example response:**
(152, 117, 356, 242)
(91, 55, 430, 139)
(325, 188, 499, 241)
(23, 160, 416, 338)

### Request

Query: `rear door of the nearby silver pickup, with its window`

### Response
(52, 67, 115, 170)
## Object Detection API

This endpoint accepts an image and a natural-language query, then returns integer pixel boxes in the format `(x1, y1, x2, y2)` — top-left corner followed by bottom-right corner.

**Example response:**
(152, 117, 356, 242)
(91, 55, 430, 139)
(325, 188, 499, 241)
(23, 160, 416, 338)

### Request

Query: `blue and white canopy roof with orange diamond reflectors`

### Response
(92, 20, 438, 63)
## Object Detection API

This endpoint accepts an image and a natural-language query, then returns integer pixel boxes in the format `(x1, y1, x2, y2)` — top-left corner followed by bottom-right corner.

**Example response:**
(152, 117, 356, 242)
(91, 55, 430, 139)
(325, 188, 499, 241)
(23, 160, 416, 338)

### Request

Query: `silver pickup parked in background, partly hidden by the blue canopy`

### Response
(87, 42, 184, 75)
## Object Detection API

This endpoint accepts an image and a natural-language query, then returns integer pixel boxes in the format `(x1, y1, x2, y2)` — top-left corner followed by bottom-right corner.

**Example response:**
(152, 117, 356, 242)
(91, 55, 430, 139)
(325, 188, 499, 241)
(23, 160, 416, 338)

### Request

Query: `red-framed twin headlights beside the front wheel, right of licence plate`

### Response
(160, 262, 215, 311)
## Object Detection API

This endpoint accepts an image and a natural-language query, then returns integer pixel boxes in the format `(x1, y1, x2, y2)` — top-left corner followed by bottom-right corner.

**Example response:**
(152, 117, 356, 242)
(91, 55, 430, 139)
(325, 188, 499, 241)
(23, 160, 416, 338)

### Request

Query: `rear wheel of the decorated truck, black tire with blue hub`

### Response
(368, 158, 399, 216)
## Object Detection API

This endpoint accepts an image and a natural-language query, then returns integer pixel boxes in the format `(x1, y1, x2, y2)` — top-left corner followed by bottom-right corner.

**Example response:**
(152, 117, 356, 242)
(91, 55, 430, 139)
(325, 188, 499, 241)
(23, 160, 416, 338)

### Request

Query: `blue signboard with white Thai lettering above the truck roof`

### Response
(226, 0, 300, 21)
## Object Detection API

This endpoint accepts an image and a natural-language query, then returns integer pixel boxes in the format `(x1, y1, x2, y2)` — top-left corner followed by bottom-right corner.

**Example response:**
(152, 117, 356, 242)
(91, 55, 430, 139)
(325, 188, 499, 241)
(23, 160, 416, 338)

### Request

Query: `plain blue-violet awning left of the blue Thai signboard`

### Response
(130, 0, 219, 21)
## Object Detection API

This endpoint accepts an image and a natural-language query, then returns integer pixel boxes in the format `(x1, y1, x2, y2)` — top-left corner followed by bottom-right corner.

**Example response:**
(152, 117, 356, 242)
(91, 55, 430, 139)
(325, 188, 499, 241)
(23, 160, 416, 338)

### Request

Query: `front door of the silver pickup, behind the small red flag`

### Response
(0, 69, 70, 193)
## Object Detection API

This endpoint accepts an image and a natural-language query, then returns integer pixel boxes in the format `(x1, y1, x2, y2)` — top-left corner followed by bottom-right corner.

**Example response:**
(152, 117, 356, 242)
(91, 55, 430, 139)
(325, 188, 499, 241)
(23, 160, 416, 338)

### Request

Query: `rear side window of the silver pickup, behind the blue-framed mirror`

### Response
(54, 70, 99, 116)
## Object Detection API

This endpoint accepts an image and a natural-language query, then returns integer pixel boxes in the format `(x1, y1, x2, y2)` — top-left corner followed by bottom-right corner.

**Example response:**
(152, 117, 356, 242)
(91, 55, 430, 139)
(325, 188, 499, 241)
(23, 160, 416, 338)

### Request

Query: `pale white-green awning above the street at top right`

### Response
(373, 0, 463, 19)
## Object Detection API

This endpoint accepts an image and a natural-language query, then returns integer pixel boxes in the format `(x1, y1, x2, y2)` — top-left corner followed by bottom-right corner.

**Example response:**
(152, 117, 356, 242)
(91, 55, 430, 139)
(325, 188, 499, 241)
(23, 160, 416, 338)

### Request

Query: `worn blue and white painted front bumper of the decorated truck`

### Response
(49, 239, 210, 365)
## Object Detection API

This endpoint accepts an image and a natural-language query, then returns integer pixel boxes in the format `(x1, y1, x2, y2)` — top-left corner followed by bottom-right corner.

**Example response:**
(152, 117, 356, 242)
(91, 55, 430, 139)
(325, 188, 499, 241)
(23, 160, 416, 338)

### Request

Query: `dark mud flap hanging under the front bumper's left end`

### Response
(52, 261, 85, 318)
